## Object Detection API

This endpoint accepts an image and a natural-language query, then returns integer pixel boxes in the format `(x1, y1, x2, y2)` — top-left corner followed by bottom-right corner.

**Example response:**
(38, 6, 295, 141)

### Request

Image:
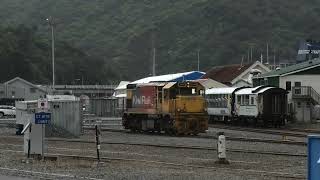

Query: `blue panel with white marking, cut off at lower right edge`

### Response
(308, 135, 320, 180)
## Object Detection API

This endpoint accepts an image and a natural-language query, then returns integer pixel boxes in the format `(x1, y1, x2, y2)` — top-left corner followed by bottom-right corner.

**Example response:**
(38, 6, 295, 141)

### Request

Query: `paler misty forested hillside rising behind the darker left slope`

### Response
(0, 0, 320, 80)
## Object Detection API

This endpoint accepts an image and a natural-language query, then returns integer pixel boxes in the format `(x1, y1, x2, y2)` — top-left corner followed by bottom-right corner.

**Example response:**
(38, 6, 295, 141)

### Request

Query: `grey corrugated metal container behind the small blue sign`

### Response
(16, 98, 83, 137)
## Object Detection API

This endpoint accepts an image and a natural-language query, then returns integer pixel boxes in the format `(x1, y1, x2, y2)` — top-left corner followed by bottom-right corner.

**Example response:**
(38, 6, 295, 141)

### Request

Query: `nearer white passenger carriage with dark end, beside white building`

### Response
(234, 86, 287, 126)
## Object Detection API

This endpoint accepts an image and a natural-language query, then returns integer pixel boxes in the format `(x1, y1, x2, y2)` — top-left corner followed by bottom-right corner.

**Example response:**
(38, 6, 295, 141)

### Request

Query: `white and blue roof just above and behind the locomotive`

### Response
(130, 71, 205, 84)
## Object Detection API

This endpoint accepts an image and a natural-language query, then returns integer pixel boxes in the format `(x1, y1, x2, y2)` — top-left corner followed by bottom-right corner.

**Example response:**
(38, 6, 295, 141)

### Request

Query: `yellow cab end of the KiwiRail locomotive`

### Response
(162, 82, 208, 134)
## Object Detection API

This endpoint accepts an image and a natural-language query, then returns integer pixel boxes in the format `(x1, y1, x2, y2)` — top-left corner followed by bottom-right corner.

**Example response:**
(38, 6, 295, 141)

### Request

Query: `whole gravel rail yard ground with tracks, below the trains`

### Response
(0, 117, 318, 180)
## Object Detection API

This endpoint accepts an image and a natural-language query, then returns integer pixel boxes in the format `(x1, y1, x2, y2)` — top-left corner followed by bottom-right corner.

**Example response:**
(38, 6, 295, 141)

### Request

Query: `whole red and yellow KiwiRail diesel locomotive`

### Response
(122, 81, 208, 135)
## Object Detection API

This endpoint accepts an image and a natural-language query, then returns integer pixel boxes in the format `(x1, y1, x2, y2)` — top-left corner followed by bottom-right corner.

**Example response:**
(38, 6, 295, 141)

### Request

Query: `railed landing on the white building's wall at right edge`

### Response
(292, 86, 320, 104)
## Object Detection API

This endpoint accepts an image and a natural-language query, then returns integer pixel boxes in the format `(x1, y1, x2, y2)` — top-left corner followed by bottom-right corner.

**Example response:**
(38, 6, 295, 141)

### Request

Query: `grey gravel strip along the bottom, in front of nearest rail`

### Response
(0, 152, 304, 180)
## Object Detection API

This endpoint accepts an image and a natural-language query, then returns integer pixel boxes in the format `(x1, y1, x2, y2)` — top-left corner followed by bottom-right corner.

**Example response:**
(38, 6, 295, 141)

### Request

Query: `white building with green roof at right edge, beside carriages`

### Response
(253, 58, 320, 122)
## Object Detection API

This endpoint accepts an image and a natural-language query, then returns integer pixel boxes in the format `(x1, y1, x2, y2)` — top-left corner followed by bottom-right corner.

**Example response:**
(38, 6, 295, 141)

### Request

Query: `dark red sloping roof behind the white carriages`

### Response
(201, 63, 252, 86)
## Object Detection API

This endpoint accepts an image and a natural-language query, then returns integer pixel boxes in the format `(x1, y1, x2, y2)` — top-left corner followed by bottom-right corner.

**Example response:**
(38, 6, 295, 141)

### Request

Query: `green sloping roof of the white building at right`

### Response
(256, 58, 320, 78)
